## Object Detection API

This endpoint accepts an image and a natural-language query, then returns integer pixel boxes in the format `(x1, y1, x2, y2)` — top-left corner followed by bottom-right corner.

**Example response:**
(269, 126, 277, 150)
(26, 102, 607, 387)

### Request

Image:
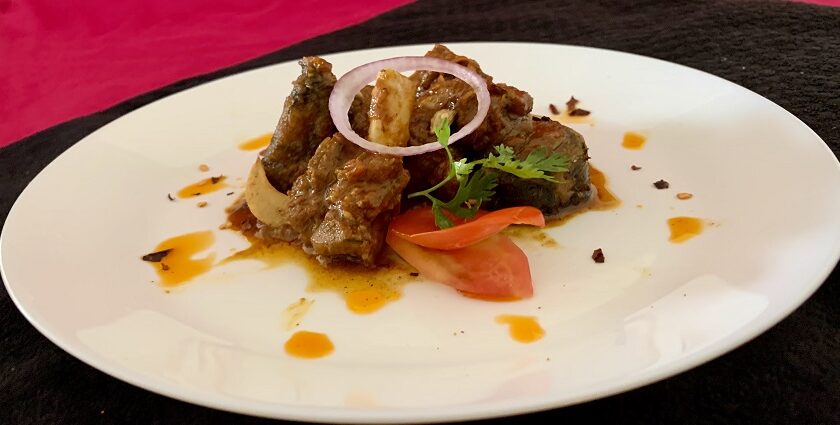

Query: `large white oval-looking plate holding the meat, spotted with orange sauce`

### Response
(0, 43, 840, 422)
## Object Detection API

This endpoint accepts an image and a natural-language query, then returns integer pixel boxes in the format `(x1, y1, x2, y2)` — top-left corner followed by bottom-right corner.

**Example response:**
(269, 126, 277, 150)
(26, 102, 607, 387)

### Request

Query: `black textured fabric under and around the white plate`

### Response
(0, 0, 840, 424)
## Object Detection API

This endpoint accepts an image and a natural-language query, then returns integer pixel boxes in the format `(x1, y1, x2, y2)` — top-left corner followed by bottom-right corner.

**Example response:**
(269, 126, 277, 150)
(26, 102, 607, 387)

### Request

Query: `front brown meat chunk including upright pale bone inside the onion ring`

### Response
(289, 70, 415, 266)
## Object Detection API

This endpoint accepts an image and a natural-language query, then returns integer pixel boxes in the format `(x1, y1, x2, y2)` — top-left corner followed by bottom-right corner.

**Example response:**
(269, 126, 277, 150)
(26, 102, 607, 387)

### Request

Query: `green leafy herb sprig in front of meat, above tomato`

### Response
(408, 118, 568, 229)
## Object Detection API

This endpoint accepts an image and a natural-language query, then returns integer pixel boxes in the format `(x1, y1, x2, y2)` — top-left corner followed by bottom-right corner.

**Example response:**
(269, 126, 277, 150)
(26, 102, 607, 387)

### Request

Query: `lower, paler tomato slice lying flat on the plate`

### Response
(386, 230, 534, 298)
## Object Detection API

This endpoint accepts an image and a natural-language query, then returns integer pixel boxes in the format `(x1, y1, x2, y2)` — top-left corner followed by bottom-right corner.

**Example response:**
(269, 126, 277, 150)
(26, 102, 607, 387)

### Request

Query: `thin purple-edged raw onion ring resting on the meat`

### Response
(330, 56, 490, 156)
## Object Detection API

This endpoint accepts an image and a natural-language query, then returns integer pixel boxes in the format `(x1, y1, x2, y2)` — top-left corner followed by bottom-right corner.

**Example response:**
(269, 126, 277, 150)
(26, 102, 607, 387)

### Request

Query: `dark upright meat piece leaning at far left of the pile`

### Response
(262, 56, 336, 193)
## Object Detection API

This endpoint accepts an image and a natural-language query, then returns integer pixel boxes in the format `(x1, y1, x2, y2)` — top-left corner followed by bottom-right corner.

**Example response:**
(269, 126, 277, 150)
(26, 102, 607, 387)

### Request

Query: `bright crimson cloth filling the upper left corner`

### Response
(0, 0, 411, 147)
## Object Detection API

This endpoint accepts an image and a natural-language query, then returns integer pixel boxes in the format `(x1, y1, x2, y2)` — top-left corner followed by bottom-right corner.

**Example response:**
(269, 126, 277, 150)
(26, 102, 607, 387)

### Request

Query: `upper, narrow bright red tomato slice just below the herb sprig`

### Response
(390, 207, 545, 250)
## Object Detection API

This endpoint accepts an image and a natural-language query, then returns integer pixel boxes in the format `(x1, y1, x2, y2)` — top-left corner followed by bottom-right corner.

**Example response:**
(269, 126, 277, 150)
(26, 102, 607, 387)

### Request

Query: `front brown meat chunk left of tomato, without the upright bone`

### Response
(289, 134, 408, 266)
